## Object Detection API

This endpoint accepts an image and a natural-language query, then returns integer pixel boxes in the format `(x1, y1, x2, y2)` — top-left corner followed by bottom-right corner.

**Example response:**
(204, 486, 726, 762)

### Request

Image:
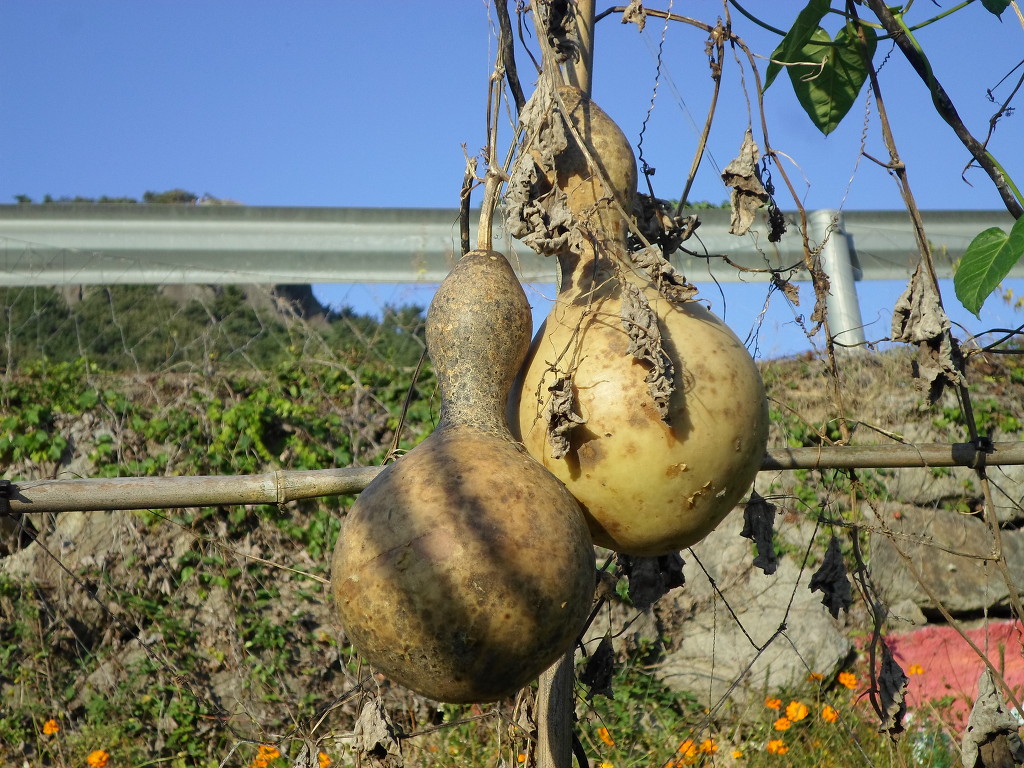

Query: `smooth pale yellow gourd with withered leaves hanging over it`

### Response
(509, 87, 768, 555)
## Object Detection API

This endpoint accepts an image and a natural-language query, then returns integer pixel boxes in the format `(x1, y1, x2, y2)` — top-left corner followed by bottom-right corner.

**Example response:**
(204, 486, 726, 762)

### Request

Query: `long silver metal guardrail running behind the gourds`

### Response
(0, 204, 1024, 287)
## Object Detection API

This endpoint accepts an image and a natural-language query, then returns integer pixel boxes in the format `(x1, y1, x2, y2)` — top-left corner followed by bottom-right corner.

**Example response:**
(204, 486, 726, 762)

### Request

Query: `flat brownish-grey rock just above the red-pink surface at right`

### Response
(869, 503, 1024, 617)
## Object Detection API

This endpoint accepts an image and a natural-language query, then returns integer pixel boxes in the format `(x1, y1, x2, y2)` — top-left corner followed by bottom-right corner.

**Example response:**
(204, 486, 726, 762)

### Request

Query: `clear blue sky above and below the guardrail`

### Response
(0, 0, 1024, 355)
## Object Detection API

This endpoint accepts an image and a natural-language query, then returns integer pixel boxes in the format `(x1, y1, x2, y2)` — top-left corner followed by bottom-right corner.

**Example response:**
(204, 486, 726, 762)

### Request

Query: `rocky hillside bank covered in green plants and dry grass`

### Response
(0, 292, 1024, 766)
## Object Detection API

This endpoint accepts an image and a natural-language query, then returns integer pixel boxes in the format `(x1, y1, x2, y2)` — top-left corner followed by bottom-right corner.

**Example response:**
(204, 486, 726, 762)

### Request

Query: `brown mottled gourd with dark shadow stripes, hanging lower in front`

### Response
(332, 251, 595, 702)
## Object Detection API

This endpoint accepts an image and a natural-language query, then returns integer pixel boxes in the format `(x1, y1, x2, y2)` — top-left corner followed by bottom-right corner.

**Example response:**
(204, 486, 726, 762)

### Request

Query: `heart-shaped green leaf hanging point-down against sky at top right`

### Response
(788, 24, 878, 136)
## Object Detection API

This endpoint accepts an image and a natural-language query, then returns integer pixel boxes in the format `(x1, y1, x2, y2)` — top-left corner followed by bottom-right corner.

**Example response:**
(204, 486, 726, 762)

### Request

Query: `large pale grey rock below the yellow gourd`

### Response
(656, 512, 853, 706)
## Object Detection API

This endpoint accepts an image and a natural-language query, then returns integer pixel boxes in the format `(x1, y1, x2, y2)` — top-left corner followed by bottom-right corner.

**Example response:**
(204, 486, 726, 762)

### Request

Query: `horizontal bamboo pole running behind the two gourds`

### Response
(8, 442, 1024, 512)
